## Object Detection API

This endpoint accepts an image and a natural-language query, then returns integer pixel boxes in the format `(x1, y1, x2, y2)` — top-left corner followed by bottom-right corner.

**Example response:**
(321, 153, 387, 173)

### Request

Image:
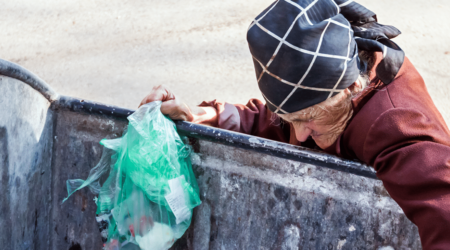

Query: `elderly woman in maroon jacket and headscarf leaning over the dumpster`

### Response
(141, 0, 450, 249)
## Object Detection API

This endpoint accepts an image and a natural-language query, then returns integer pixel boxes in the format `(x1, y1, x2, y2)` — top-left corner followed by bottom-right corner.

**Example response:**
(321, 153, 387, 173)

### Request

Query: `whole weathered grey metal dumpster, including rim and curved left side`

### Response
(0, 60, 421, 250)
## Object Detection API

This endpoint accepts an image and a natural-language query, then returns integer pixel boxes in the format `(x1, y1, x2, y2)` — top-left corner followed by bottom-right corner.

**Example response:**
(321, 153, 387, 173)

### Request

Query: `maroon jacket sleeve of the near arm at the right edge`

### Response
(363, 108, 450, 250)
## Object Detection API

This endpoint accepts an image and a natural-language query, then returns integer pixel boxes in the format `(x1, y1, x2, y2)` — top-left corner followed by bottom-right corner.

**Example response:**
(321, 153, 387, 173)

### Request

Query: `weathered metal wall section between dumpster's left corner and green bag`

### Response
(50, 110, 127, 250)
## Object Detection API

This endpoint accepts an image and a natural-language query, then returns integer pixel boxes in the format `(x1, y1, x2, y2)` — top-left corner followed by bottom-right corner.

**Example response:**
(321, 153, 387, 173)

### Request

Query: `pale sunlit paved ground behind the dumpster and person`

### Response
(0, 0, 450, 124)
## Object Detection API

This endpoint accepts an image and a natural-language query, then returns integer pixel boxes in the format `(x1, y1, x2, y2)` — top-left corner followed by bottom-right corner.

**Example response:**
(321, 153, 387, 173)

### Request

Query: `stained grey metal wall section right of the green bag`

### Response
(176, 141, 421, 249)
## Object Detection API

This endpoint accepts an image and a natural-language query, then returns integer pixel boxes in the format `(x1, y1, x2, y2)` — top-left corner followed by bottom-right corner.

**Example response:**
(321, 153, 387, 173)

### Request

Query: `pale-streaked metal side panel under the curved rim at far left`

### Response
(0, 76, 53, 249)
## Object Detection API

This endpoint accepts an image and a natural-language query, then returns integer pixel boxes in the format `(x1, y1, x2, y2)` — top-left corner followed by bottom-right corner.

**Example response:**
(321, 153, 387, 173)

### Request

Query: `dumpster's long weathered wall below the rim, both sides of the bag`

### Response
(52, 110, 421, 250)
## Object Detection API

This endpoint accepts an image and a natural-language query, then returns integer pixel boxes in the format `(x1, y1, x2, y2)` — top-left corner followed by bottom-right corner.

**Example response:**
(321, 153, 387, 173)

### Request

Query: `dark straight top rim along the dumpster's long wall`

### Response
(52, 96, 378, 179)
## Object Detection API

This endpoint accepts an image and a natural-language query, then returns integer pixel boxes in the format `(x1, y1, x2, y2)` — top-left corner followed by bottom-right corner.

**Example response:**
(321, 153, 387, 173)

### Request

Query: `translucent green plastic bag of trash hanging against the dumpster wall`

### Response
(63, 102, 200, 250)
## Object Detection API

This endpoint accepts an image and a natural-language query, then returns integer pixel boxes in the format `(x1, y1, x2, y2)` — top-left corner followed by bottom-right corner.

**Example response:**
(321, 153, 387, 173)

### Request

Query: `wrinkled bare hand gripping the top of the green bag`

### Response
(139, 85, 194, 121)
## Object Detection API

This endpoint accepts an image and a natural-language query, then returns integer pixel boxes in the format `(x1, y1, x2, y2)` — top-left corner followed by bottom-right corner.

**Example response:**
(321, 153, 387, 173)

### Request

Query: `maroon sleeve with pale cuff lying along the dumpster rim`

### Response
(200, 99, 295, 143)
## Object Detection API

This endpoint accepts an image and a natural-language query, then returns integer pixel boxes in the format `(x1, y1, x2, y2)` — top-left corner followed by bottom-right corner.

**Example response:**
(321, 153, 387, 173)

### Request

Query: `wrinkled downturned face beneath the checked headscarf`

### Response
(279, 88, 352, 149)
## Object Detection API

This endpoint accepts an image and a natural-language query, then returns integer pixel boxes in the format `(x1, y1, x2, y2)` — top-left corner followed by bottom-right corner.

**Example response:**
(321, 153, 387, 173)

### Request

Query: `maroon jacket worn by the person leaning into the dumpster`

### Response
(202, 53, 450, 250)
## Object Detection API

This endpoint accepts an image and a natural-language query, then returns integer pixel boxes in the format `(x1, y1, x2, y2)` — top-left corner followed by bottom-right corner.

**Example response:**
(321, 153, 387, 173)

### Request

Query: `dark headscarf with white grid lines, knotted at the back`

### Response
(247, 0, 404, 113)
